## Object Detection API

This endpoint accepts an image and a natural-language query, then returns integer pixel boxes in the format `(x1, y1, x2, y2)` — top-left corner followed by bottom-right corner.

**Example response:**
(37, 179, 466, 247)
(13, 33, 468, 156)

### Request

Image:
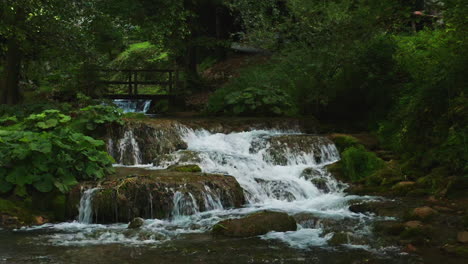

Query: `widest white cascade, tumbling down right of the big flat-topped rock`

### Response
(184, 130, 343, 205)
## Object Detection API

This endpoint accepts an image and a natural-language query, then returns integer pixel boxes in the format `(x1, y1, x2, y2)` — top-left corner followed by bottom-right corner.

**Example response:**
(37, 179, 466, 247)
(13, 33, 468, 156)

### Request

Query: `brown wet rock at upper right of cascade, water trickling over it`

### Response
(258, 135, 337, 166)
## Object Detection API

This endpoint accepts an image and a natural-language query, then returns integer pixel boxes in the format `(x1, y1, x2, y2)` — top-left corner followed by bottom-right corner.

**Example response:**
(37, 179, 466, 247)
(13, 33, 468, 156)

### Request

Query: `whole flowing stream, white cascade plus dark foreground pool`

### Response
(0, 128, 414, 263)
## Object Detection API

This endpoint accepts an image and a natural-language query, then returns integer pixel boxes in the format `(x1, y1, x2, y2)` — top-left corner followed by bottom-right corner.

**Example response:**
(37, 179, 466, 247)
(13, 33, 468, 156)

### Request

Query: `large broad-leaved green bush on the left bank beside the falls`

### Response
(0, 110, 114, 196)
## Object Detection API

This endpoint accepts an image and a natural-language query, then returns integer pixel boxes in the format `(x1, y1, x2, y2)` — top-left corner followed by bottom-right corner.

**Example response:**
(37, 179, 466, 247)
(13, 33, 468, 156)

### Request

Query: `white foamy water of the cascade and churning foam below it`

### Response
(17, 128, 380, 249)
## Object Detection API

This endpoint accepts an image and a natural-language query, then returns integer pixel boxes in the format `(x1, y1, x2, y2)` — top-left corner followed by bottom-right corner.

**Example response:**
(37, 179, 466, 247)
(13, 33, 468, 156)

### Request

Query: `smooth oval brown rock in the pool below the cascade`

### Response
(212, 211, 297, 237)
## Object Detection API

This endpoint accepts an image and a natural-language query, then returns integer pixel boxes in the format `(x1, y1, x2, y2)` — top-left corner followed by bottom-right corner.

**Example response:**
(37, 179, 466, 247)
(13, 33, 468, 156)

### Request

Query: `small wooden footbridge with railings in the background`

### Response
(96, 69, 179, 100)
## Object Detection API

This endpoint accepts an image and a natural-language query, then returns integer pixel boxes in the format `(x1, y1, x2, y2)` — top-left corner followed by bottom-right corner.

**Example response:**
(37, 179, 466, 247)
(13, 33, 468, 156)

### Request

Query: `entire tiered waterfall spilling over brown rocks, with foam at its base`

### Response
(27, 126, 378, 252)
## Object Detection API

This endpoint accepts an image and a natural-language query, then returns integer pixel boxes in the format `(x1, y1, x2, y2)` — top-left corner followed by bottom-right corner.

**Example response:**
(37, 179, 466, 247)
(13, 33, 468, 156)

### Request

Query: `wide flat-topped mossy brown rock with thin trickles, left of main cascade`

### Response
(70, 168, 245, 223)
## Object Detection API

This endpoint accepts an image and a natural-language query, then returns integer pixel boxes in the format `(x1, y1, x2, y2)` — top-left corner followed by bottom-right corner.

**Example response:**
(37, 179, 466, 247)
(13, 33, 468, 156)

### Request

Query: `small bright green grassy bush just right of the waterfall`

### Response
(341, 146, 385, 182)
